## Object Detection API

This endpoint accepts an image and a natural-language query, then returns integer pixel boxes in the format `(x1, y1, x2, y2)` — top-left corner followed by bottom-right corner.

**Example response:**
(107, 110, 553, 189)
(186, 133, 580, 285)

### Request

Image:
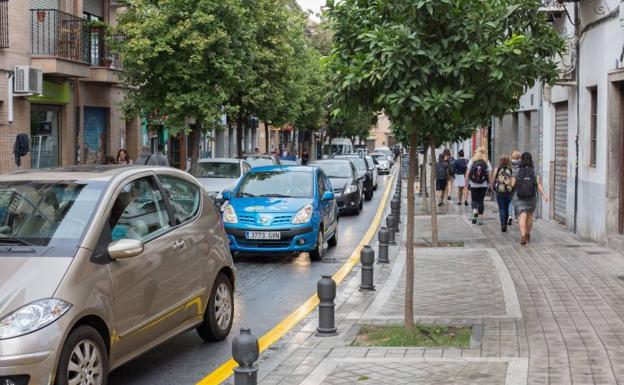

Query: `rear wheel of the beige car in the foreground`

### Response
(197, 273, 234, 342)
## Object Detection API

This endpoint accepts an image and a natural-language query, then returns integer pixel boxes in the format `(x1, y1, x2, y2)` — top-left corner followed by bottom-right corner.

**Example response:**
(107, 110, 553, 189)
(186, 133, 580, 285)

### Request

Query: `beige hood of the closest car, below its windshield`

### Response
(0, 257, 72, 318)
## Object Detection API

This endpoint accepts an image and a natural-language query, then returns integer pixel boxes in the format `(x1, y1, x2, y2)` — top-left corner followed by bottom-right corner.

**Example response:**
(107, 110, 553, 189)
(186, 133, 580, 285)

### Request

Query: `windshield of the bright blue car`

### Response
(236, 171, 314, 198)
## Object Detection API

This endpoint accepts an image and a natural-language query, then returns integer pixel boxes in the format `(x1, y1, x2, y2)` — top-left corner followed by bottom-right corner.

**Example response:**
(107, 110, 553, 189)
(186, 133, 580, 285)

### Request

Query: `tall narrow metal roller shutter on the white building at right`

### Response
(553, 102, 568, 224)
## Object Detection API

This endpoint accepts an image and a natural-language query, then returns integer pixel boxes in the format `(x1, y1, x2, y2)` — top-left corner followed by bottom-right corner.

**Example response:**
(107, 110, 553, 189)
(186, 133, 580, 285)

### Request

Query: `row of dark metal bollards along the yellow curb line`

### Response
(232, 172, 401, 385)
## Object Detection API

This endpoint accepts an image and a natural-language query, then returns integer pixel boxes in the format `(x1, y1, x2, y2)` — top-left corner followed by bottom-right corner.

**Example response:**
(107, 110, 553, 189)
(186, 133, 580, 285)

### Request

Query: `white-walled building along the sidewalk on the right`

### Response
(494, 0, 624, 249)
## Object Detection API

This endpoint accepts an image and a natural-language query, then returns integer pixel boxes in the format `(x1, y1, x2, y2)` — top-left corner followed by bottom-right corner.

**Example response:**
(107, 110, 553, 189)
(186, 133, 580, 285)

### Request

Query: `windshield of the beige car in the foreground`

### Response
(0, 181, 106, 247)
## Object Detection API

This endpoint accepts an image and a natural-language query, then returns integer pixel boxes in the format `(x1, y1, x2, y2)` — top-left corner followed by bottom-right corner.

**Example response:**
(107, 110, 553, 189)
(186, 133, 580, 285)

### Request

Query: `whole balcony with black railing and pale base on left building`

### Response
(31, 9, 121, 82)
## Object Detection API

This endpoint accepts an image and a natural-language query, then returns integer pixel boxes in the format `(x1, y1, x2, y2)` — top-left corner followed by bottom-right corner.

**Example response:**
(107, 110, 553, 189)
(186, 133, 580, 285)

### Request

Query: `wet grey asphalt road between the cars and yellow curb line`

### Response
(109, 172, 389, 385)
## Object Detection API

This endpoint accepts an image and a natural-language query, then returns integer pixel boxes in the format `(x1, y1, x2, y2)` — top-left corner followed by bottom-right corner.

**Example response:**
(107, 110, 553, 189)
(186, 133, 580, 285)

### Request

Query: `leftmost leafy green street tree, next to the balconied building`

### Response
(115, 0, 252, 172)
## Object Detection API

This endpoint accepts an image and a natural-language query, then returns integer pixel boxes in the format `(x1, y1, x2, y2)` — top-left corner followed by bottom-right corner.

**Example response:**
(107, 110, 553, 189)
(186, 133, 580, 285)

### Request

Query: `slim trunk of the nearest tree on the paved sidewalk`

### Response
(405, 131, 418, 332)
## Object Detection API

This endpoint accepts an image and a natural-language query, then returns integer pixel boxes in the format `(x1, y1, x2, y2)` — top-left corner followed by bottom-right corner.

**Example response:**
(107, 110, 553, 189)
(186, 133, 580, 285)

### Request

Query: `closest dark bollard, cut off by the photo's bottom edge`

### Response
(232, 329, 260, 385)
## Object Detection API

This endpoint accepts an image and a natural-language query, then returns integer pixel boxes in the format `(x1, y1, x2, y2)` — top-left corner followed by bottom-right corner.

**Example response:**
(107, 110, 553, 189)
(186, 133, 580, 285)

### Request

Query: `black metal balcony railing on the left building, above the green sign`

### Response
(31, 9, 121, 68)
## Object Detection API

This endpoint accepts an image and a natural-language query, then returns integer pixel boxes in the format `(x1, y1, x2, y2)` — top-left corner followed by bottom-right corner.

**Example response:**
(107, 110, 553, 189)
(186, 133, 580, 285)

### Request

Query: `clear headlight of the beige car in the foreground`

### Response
(0, 298, 72, 340)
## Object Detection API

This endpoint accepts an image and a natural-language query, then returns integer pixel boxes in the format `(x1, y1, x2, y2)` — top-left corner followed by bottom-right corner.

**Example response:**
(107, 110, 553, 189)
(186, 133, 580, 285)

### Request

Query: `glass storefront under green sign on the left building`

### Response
(28, 79, 71, 168)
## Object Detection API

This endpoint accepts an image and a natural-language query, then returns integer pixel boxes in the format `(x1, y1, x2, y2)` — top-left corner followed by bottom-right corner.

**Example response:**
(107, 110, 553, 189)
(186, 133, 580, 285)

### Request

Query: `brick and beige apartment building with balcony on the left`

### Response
(0, 0, 140, 172)
